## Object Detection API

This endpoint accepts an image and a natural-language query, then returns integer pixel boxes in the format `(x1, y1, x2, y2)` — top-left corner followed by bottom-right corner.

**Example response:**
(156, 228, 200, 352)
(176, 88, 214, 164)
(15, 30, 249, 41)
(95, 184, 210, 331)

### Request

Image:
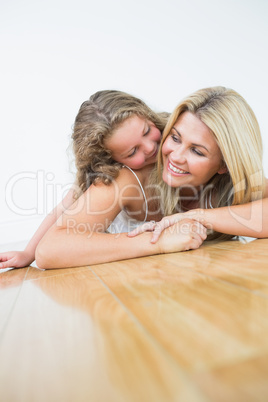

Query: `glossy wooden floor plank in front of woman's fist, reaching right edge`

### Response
(91, 256, 268, 372)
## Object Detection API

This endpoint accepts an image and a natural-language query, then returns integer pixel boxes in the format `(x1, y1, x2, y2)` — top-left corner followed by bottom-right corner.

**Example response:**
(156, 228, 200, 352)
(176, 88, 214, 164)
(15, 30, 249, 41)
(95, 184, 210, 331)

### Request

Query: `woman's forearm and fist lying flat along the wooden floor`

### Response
(35, 219, 206, 269)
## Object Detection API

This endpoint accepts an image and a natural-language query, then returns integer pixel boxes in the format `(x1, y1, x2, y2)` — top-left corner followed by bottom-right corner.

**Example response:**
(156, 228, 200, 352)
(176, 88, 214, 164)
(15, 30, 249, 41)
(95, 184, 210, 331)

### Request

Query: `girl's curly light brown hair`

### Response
(72, 90, 168, 192)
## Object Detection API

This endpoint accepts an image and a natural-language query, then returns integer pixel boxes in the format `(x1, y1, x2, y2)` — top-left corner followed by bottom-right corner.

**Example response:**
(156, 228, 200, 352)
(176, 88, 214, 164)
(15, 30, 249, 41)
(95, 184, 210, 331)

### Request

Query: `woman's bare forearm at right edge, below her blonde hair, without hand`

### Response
(191, 198, 268, 238)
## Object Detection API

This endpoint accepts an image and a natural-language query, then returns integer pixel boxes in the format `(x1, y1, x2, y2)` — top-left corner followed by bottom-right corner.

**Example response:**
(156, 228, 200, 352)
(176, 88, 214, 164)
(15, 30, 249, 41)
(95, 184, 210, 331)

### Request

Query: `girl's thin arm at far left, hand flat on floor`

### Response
(0, 189, 74, 269)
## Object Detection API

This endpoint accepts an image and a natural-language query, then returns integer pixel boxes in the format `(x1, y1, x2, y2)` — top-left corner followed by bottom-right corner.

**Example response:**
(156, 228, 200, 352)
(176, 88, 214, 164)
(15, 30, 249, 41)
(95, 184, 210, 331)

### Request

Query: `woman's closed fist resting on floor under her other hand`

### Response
(158, 219, 207, 253)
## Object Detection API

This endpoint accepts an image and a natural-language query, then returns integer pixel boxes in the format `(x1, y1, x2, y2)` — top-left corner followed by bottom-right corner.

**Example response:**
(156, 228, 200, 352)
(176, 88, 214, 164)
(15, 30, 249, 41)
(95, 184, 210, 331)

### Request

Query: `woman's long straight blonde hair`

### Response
(157, 87, 265, 239)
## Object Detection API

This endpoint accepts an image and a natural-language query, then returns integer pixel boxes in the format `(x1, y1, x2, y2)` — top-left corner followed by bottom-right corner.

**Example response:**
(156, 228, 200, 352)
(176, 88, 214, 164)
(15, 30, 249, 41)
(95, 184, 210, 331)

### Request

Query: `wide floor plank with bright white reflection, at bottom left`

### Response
(0, 269, 207, 402)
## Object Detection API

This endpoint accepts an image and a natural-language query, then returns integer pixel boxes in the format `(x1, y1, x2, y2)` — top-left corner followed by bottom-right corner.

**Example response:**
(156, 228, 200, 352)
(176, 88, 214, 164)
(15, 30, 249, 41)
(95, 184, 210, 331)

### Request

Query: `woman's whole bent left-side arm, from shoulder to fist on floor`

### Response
(36, 170, 206, 269)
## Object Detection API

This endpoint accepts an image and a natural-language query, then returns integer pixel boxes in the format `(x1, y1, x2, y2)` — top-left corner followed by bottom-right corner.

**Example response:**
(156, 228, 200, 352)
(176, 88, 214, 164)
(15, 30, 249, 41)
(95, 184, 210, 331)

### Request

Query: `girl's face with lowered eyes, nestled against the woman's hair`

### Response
(105, 116, 161, 169)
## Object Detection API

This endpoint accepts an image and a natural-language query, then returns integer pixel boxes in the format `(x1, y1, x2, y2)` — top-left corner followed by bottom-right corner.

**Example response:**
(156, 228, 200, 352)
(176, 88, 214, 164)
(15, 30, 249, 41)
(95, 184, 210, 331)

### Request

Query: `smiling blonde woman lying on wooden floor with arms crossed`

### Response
(36, 87, 268, 268)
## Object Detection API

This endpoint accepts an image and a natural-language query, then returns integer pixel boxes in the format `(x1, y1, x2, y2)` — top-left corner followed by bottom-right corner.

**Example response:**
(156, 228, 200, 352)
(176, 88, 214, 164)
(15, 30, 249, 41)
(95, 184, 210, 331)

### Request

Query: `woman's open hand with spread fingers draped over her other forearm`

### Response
(128, 213, 185, 243)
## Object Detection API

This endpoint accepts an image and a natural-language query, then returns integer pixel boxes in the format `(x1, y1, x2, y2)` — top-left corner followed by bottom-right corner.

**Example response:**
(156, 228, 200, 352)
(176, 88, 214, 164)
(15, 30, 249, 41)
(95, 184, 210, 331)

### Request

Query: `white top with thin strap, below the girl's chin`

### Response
(107, 166, 148, 233)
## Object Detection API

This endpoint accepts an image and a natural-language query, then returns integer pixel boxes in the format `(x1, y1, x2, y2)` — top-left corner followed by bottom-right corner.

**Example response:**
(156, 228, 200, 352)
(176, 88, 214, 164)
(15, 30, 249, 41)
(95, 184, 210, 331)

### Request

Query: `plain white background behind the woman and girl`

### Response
(0, 0, 268, 244)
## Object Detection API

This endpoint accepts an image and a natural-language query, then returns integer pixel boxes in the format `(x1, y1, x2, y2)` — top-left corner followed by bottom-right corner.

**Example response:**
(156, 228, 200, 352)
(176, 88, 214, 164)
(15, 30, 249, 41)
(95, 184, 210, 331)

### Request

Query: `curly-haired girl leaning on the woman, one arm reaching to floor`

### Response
(0, 91, 203, 268)
